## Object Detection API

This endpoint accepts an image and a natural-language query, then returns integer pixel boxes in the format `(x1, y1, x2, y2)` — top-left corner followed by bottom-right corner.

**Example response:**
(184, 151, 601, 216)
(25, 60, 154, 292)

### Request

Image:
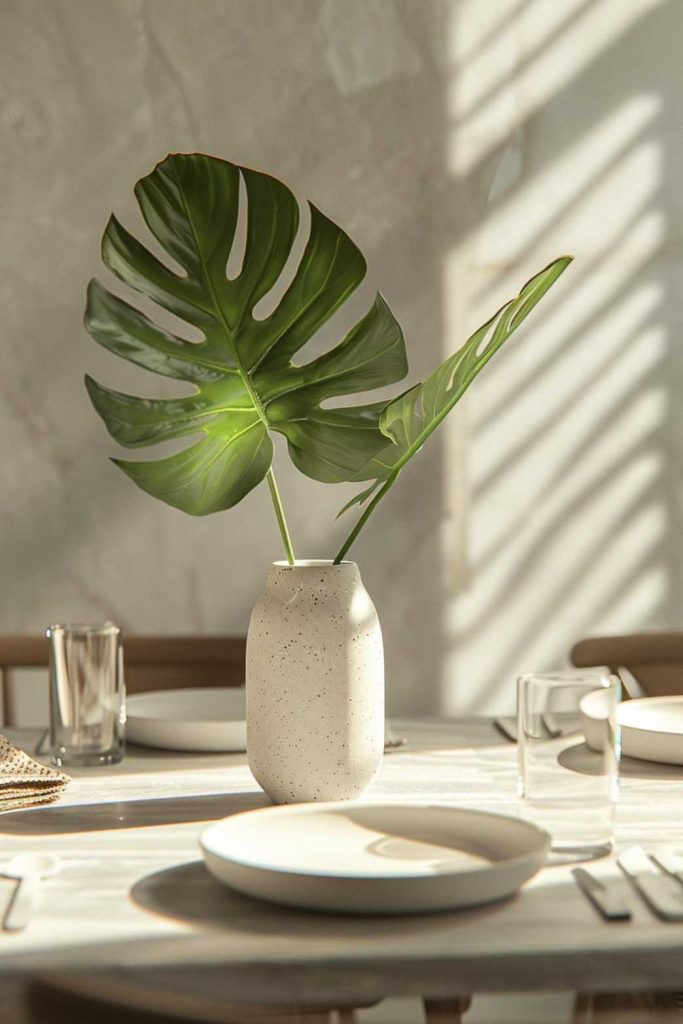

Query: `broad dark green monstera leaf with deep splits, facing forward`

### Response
(85, 154, 408, 515)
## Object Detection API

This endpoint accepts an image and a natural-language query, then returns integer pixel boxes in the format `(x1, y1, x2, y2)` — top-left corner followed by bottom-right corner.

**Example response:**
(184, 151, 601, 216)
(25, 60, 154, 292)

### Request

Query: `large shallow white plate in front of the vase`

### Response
(200, 803, 550, 913)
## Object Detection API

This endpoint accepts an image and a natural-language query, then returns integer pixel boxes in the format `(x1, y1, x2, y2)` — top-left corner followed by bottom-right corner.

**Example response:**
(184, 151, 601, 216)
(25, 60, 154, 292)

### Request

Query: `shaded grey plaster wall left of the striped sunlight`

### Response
(0, 0, 454, 708)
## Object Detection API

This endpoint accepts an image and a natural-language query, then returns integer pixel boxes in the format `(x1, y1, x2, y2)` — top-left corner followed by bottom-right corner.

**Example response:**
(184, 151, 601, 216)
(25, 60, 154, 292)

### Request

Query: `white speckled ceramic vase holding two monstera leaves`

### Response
(247, 560, 384, 804)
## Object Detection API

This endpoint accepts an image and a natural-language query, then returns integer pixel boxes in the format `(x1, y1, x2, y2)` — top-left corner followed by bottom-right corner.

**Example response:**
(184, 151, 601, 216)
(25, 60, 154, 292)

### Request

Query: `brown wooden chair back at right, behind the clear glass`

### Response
(570, 633, 683, 697)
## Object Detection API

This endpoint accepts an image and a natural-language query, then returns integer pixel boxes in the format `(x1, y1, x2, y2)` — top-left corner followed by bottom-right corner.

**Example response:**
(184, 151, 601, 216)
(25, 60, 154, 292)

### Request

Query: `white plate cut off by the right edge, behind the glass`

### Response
(616, 696, 683, 765)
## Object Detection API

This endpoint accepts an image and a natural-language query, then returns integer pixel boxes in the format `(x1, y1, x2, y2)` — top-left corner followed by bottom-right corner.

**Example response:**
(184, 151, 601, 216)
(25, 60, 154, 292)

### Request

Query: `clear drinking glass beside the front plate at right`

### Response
(517, 669, 621, 860)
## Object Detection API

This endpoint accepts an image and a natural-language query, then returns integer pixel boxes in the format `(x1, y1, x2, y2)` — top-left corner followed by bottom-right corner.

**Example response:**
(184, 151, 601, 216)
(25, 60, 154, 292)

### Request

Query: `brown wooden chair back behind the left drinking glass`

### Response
(0, 636, 247, 725)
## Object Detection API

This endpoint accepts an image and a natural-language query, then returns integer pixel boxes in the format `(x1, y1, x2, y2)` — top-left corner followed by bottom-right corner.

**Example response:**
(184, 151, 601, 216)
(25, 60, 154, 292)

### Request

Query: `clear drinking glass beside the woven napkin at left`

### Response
(47, 623, 126, 765)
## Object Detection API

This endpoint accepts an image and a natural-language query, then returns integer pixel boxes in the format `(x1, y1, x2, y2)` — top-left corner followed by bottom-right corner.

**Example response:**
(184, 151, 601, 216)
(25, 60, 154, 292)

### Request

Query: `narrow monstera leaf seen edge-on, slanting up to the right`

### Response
(339, 256, 571, 528)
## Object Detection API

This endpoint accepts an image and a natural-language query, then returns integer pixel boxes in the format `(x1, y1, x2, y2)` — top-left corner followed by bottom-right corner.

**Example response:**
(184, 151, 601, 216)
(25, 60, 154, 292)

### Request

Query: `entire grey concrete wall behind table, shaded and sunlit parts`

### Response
(0, 0, 683, 713)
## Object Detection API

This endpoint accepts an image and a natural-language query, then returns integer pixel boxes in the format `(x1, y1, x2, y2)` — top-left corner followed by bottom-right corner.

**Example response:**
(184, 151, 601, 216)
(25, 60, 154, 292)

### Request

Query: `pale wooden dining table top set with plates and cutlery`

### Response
(0, 718, 683, 1018)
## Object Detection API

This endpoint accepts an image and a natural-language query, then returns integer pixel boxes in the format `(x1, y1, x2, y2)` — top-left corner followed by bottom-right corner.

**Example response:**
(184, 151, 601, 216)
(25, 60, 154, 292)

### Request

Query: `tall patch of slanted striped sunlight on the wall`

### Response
(442, 0, 673, 713)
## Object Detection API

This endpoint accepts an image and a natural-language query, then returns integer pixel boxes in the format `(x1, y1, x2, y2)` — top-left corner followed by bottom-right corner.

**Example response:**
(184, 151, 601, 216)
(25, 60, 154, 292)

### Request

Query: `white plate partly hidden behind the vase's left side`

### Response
(126, 687, 247, 753)
